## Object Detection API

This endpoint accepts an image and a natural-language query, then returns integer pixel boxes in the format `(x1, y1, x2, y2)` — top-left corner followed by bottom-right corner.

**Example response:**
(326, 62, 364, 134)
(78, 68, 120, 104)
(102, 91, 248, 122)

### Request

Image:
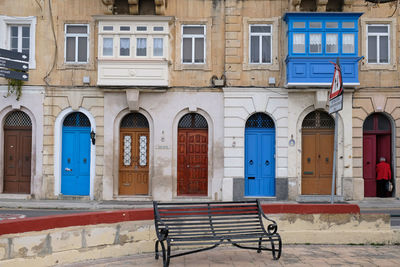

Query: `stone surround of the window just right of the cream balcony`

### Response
(174, 18, 212, 71)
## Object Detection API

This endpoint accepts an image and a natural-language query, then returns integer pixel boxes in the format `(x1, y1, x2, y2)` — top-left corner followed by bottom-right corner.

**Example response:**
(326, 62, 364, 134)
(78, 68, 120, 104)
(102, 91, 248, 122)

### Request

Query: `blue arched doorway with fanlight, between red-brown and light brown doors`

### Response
(244, 113, 275, 196)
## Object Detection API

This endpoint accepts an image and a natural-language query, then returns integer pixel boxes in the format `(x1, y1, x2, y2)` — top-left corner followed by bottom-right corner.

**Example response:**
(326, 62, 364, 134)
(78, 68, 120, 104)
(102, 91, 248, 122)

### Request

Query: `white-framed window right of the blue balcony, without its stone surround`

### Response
(367, 24, 389, 64)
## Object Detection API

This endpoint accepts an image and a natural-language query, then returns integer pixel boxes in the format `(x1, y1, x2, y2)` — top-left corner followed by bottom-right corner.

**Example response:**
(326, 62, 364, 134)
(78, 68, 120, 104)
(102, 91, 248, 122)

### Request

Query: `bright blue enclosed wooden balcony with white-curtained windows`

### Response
(284, 12, 362, 87)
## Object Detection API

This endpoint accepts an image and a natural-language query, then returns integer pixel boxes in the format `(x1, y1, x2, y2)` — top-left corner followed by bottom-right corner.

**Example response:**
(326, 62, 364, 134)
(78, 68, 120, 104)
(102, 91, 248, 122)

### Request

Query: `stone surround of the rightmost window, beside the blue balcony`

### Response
(360, 17, 397, 71)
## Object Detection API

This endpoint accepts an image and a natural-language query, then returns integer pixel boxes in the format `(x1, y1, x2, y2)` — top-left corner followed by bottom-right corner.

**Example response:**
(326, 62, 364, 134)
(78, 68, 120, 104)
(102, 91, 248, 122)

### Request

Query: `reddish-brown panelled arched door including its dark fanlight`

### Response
(177, 113, 208, 196)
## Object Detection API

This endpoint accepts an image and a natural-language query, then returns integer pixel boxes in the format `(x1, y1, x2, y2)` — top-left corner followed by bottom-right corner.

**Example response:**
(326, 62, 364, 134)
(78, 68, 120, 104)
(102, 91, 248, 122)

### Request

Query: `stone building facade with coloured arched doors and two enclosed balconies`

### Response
(0, 0, 400, 201)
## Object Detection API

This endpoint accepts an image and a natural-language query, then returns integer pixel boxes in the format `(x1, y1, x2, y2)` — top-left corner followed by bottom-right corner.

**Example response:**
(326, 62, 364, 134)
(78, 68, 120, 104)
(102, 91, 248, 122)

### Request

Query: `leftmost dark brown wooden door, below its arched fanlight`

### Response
(4, 128, 32, 194)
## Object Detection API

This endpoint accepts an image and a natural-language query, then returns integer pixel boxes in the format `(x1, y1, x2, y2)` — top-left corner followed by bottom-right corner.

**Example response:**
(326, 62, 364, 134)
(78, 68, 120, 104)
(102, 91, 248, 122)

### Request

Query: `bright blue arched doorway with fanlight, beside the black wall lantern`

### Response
(61, 112, 91, 196)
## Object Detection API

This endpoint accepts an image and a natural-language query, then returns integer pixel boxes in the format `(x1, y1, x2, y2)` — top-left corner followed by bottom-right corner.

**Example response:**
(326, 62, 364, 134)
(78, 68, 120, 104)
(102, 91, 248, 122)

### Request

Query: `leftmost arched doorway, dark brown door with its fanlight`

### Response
(3, 111, 32, 194)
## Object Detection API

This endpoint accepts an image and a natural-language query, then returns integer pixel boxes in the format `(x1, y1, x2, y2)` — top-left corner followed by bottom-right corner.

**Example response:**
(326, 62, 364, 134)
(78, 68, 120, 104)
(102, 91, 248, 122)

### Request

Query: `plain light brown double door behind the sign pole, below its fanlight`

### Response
(301, 129, 334, 195)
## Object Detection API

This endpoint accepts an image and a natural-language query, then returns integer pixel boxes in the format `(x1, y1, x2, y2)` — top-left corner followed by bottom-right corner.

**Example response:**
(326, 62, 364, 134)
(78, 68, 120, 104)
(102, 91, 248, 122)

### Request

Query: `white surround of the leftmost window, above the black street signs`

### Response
(0, 16, 36, 69)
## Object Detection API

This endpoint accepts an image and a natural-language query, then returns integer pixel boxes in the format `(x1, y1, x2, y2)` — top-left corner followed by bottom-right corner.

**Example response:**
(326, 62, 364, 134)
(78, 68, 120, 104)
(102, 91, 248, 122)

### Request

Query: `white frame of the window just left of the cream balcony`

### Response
(64, 23, 90, 65)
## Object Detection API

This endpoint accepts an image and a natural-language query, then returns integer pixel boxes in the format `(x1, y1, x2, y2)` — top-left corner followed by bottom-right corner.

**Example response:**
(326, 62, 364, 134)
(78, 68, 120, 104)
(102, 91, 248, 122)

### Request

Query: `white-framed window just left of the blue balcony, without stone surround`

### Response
(249, 25, 272, 64)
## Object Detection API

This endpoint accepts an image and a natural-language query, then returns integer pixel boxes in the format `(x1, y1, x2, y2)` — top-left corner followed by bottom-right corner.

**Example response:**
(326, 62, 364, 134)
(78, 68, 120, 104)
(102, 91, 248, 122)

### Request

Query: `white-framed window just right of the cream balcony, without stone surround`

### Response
(182, 25, 206, 64)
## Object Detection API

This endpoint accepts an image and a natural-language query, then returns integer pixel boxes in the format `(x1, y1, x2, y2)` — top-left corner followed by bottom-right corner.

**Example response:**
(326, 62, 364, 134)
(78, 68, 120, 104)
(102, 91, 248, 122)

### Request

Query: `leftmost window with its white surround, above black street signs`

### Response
(0, 15, 36, 69)
